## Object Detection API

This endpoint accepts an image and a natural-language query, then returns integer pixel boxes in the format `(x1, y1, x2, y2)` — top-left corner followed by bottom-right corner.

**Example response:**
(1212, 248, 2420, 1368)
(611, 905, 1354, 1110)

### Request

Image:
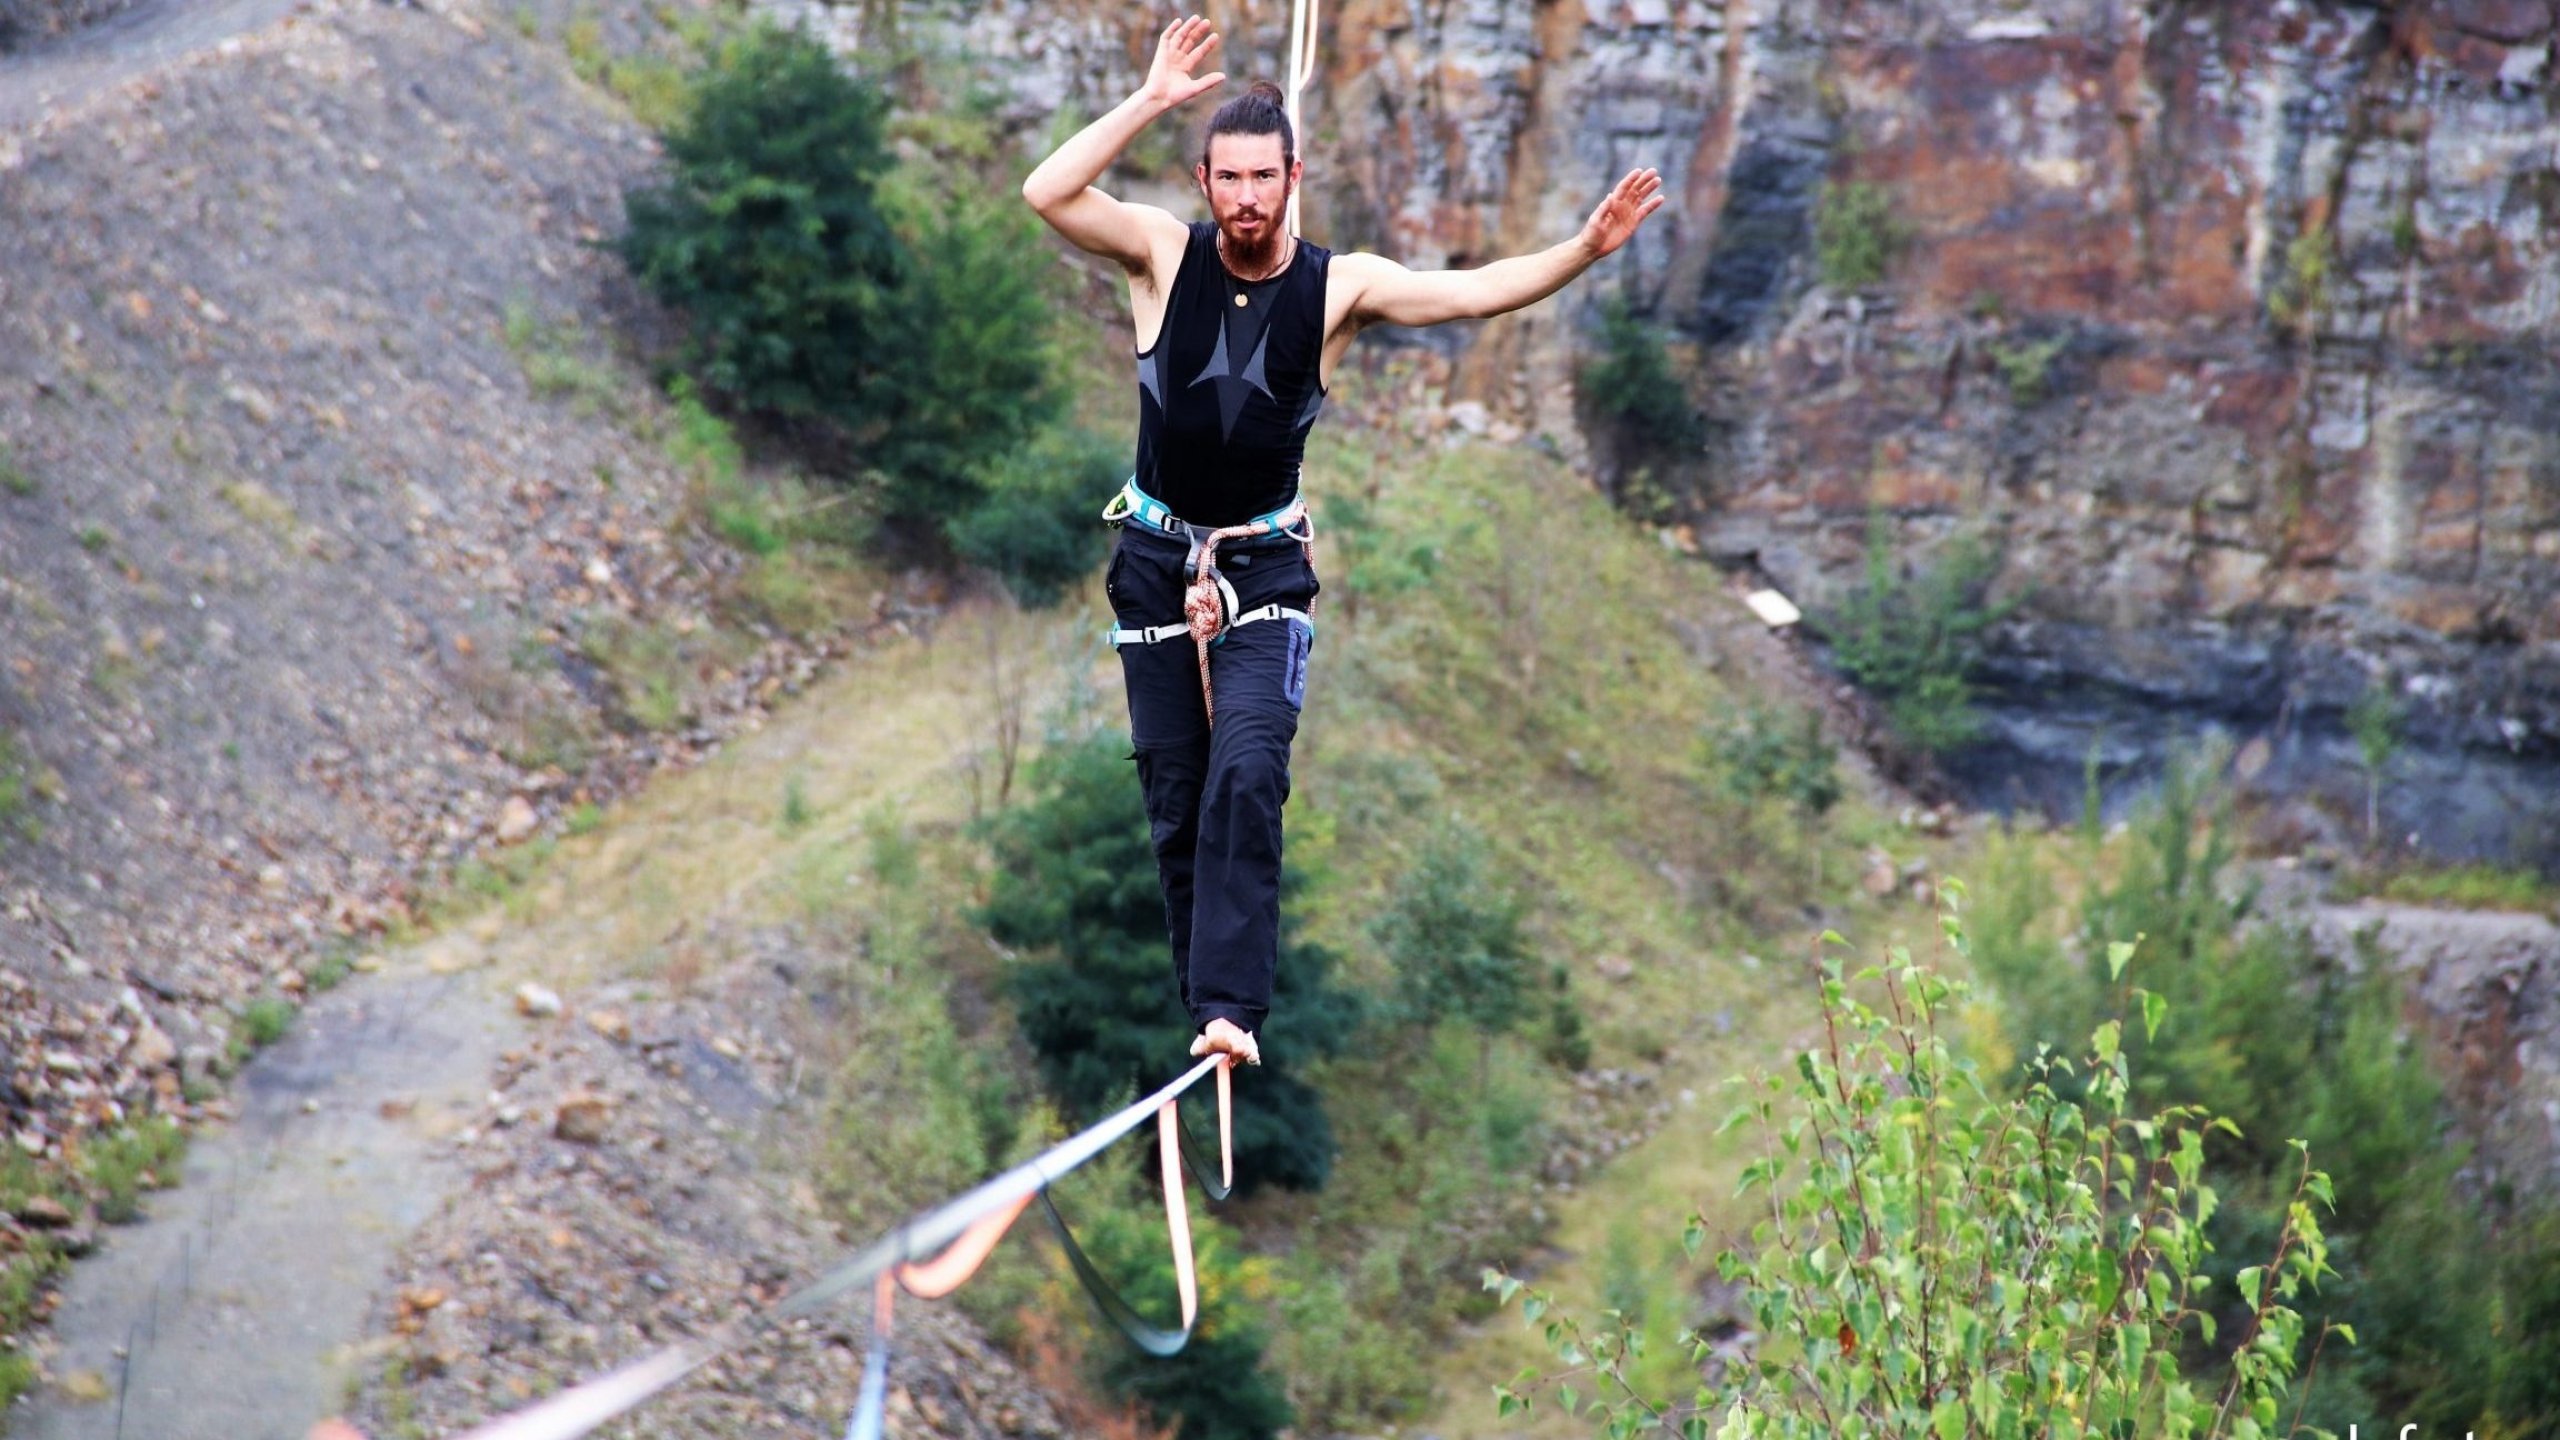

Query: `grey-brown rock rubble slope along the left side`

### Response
(0, 3, 839, 1153)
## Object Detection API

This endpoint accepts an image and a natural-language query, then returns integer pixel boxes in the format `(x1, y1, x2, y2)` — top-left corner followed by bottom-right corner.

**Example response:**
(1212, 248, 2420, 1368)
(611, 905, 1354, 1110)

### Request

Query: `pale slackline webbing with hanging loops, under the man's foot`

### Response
(456, 1056, 1234, 1440)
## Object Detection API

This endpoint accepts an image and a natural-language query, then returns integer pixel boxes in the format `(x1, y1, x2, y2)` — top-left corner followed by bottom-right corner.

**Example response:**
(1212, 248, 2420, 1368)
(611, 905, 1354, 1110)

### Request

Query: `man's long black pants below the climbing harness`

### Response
(1106, 525, 1321, 1033)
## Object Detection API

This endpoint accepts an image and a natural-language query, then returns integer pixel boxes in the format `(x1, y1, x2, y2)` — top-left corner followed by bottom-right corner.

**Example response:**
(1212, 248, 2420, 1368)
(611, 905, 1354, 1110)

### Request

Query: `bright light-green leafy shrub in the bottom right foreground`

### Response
(1485, 917, 2353, 1440)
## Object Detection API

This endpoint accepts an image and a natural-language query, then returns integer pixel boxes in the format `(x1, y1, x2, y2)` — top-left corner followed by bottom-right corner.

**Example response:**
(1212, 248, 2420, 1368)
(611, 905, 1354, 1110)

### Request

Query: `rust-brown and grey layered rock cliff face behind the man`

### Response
(942, 0, 2560, 856)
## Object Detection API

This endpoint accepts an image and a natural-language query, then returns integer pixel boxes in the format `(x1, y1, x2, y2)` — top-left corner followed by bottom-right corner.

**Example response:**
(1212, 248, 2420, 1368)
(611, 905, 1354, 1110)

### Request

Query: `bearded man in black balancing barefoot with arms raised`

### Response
(1021, 15, 1661, 1063)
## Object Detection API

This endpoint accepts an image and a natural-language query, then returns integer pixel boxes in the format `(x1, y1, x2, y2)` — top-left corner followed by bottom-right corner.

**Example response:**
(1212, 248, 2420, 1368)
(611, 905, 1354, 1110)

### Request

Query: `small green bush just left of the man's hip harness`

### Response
(945, 425, 1129, 607)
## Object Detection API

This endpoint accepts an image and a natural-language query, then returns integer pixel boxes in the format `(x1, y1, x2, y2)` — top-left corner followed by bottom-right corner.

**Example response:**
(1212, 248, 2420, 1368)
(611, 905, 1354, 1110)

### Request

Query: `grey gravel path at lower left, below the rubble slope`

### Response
(10, 961, 522, 1440)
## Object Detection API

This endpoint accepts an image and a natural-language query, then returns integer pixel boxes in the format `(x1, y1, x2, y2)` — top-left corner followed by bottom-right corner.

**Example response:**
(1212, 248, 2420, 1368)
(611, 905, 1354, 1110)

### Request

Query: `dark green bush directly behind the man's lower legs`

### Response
(980, 735, 1357, 1189)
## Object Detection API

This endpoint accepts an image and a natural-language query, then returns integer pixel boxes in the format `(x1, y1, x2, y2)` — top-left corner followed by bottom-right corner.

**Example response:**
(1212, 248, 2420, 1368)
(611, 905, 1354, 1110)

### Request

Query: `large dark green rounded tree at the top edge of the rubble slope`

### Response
(620, 26, 909, 425)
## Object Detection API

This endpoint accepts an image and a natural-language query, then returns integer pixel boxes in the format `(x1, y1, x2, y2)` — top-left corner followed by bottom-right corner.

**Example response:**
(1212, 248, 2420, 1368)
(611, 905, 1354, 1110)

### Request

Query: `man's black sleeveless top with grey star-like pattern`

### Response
(1137, 220, 1334, 525)
